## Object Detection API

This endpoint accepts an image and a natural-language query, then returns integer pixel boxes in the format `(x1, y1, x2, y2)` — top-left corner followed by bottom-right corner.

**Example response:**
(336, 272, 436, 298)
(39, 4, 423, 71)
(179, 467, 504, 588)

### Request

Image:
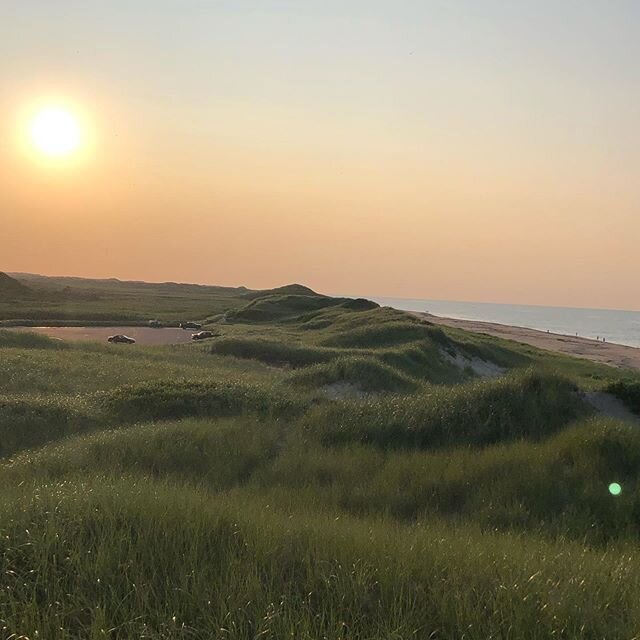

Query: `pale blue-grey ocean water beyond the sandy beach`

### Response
(369, 297, 640, 347)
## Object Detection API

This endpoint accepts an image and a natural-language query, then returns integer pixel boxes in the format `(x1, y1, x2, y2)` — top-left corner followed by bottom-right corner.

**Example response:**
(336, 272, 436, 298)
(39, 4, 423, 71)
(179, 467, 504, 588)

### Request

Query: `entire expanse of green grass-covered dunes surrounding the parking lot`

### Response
(0, 278, 640, 640)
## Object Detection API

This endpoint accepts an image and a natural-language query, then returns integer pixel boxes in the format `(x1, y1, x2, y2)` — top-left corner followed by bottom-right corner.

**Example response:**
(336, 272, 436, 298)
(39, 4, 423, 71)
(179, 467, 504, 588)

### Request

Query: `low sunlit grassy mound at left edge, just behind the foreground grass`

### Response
(0, 419, 283, 489)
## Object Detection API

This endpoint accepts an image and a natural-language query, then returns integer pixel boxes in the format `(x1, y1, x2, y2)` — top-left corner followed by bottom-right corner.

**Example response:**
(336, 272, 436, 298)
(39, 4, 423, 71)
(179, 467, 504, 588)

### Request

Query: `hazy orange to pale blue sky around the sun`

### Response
(0, 0, 640, 309)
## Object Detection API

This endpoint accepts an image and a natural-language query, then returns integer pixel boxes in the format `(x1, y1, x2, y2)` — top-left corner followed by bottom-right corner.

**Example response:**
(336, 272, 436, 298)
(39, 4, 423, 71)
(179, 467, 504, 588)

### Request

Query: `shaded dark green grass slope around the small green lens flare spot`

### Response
(253, 421, 640, 544)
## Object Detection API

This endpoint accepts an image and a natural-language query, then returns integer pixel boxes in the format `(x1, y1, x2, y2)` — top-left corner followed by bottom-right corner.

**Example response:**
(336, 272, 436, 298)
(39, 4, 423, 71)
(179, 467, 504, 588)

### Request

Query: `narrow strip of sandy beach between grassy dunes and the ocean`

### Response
(413, 312, 640, 370)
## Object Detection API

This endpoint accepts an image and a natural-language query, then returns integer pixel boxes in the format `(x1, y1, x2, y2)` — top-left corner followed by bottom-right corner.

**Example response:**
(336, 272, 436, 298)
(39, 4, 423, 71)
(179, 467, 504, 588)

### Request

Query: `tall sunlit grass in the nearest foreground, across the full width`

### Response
(0, 477, 640, 640)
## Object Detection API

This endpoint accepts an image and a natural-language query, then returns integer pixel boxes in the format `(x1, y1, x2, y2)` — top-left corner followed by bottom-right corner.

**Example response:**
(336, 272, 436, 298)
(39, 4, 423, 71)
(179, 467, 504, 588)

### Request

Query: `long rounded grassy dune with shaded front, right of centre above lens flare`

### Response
(305, 372, 586, 449)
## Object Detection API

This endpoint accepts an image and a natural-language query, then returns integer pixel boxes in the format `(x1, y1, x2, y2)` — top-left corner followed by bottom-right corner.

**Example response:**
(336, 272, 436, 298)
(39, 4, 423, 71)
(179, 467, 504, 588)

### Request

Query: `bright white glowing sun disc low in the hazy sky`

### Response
(30, 105, 82, 158)
